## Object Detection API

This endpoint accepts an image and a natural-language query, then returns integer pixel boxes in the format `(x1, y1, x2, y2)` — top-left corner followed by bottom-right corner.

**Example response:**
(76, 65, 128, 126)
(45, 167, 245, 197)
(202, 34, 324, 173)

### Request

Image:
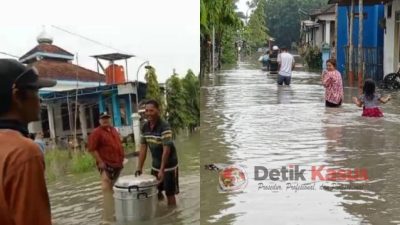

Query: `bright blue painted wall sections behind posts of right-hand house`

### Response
(336, 4, 384, 75)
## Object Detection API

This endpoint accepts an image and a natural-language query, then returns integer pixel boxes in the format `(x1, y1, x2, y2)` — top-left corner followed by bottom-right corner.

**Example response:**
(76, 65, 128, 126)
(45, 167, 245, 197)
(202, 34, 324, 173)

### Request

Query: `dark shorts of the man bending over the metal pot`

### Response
(151, 167, 179, 196)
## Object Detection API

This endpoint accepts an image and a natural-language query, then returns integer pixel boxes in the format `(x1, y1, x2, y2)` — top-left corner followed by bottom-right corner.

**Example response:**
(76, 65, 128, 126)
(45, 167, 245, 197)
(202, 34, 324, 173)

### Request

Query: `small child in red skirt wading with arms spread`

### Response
(353, 79, 391, 117)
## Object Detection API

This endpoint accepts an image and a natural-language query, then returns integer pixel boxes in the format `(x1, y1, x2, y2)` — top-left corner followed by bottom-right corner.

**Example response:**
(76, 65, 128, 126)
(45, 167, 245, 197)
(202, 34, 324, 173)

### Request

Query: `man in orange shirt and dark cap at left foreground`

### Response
(0, 59, 56, 225)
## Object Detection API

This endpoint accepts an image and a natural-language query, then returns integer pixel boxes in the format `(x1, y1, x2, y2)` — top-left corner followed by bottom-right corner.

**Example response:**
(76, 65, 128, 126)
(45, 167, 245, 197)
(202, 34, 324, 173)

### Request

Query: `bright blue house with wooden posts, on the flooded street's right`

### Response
(328, 0, 387, 84)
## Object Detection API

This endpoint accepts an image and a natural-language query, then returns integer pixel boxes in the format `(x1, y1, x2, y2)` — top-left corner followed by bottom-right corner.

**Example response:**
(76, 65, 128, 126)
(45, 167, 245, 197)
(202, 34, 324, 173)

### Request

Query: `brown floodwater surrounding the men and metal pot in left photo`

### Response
(48, 132, 200, 225)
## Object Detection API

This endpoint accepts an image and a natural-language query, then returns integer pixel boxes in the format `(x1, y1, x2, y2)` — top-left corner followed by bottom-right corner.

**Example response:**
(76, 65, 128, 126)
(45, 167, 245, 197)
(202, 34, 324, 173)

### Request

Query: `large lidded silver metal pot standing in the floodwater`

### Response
(113, 175, 158, 223)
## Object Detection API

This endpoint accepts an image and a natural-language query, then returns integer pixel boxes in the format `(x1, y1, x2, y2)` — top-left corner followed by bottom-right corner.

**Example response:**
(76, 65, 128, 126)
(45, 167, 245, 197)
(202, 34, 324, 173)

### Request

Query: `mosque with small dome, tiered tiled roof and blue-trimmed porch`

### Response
(23, 31, 146, 146)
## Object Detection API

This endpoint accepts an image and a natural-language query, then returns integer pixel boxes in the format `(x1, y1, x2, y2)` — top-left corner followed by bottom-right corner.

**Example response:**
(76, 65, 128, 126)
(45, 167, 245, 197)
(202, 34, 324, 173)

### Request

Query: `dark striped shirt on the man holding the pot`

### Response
(141, 119, 178, 171)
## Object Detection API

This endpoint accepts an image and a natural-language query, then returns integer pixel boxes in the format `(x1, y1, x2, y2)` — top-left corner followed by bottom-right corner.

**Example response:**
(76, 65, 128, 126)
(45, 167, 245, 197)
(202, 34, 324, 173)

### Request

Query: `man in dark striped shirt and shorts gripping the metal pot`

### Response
(135, 100, 179, 206)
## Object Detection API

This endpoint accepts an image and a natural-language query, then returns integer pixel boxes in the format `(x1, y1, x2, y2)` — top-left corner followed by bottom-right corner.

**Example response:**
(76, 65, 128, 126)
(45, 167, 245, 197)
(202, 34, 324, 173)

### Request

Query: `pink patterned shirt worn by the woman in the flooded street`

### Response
(322, 70, 343, 104)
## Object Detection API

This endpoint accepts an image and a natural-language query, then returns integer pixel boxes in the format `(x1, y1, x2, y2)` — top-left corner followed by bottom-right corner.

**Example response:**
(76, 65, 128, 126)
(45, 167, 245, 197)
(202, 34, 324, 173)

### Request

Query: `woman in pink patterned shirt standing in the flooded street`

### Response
(322, 59, 343, 107)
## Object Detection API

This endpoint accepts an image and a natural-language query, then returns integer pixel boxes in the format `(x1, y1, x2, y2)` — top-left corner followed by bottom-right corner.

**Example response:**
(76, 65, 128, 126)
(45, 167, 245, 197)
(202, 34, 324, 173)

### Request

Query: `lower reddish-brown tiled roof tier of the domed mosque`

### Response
(32, 60, 105, 82)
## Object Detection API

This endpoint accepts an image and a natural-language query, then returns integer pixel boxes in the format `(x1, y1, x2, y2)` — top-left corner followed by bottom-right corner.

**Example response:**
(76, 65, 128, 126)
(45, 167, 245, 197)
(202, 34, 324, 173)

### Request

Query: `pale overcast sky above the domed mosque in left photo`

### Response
(0, 0, 200, 82)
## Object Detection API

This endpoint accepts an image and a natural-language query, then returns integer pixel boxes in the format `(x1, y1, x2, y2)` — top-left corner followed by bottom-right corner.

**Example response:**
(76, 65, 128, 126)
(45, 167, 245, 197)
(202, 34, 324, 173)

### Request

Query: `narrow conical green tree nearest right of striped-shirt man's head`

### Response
(166, 74, 188, 135)
